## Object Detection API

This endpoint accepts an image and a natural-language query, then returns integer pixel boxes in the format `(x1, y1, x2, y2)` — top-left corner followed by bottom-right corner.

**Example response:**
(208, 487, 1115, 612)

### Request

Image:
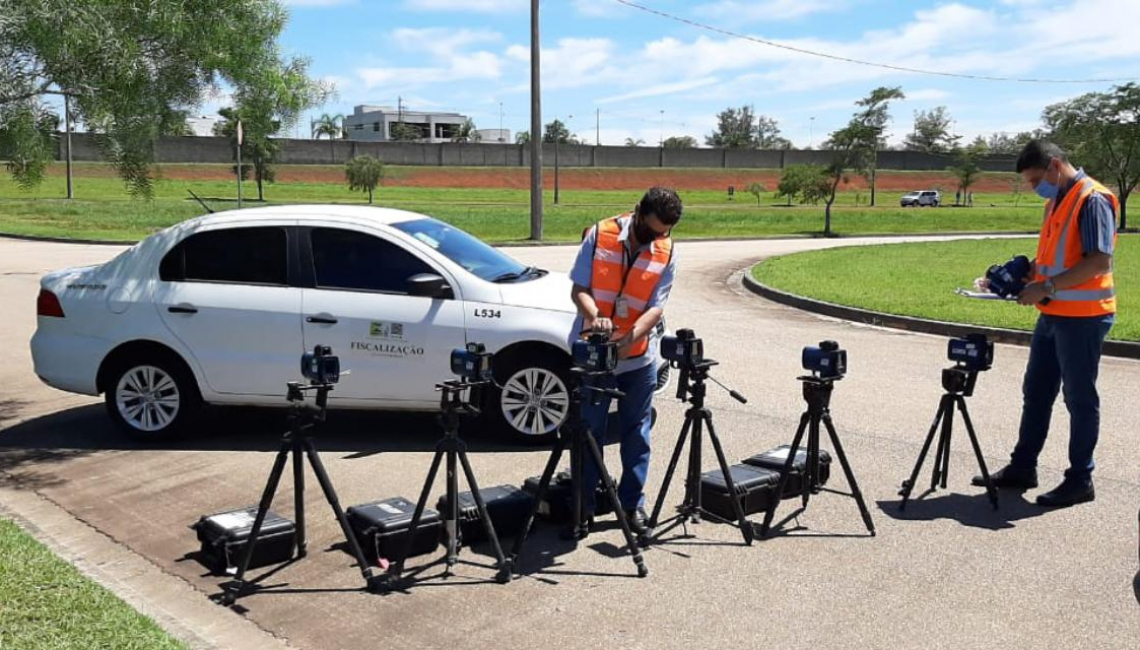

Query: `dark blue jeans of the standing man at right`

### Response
(1010, 315, 1114, 481)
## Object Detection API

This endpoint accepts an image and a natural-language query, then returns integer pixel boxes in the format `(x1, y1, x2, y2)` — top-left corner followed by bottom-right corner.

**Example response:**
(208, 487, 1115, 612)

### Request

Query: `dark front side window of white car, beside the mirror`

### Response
(309, 228, 435, 293)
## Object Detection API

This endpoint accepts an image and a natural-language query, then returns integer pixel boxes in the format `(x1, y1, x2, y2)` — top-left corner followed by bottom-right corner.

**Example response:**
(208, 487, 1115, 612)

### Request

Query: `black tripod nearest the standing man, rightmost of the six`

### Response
(898, 366, 998, 510)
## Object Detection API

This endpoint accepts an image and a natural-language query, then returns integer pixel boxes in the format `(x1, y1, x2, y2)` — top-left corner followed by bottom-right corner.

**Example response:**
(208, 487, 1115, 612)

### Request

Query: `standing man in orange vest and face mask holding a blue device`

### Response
(974, 140, 1119, 507)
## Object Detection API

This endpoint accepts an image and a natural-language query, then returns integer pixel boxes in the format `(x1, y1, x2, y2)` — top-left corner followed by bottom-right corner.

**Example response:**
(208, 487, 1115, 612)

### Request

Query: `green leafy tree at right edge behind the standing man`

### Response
(1042, 83, 1140, 230)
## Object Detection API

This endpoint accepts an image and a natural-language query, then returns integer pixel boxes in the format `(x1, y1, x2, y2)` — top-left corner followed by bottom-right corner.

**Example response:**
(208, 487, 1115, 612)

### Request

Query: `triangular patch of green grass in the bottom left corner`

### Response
(0, 519, 186, 650)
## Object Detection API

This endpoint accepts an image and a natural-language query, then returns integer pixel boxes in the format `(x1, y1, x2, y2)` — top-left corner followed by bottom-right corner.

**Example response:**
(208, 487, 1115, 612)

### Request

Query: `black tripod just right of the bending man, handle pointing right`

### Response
(650, 359, 752, 545)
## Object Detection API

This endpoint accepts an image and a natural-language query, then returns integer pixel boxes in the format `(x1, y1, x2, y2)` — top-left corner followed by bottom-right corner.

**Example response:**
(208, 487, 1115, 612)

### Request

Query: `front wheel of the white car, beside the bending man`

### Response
(486, 355, 570, 445)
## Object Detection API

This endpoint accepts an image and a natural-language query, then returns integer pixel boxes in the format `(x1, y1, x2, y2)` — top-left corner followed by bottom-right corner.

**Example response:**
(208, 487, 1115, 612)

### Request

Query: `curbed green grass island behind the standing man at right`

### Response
(752, 235, 1140, 341)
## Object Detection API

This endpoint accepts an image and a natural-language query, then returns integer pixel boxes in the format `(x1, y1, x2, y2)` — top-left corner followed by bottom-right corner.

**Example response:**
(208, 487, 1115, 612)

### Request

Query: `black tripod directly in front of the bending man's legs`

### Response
(511, 368, 649, 578)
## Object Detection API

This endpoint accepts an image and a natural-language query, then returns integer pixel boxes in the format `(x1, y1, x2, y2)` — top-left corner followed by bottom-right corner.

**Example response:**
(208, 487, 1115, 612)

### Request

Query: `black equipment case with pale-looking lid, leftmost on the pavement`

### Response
(190, 505, 296, 575)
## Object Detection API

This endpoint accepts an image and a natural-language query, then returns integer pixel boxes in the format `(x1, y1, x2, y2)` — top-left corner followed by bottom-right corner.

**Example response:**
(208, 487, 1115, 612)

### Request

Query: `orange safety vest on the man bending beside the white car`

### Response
(591, 212, 673, 358)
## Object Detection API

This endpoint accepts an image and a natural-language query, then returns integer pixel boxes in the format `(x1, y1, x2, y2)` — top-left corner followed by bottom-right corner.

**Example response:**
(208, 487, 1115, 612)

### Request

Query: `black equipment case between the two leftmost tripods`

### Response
(344, 496, 443, 562)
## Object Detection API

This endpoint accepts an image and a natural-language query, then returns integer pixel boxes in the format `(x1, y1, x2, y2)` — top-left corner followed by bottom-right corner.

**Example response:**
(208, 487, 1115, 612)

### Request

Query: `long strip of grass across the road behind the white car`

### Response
(0, 165, 1057, 243)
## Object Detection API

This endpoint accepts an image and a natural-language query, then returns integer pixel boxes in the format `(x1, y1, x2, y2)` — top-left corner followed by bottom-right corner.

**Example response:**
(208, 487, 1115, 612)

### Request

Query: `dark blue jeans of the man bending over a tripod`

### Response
(581, 364, 657, 513)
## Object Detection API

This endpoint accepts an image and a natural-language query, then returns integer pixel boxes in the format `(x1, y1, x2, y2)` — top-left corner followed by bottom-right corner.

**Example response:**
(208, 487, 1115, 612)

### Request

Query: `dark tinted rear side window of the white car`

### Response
(158, 227, 288, 285)
